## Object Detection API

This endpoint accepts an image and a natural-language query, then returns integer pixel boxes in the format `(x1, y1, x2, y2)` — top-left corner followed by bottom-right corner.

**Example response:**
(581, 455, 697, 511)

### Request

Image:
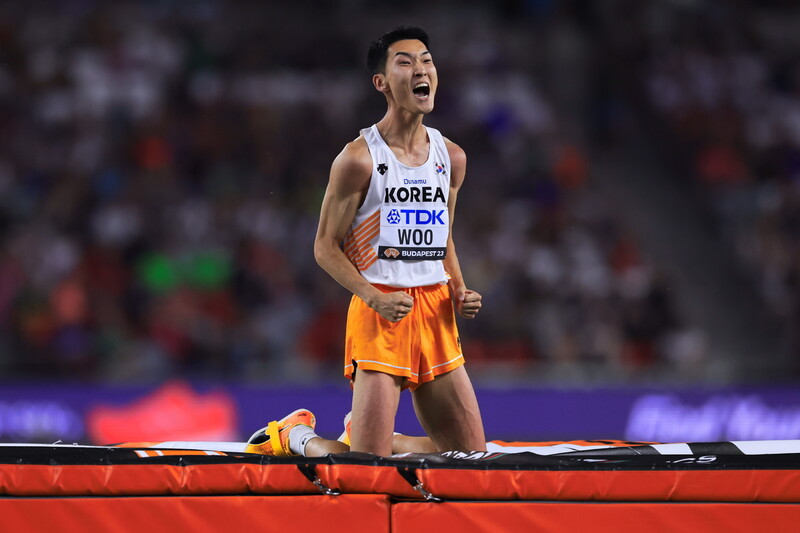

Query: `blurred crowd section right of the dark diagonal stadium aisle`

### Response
(641, 1, 800, 366)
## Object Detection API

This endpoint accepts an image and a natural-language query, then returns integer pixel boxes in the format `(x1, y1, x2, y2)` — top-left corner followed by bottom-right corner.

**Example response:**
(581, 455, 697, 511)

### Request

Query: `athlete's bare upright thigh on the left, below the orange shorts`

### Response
(350, 368, 402, 456)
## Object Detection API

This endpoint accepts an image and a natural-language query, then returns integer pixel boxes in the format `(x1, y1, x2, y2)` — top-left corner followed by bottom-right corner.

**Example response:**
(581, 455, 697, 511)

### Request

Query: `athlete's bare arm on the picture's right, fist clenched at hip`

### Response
(444, 139, 481, 318)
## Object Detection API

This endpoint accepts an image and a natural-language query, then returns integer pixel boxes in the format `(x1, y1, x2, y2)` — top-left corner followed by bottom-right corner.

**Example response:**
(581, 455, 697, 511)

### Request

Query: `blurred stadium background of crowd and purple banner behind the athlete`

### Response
(0, 0, 800, 443)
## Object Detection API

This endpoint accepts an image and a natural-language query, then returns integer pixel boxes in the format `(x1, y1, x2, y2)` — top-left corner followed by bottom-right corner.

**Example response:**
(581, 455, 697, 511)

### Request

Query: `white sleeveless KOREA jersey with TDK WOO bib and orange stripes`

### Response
(342, 125, 450, 288)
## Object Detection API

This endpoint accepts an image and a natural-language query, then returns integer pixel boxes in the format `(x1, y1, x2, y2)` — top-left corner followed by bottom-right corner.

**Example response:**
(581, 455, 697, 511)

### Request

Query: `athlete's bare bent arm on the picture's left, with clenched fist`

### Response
(314, 137, 413, 322)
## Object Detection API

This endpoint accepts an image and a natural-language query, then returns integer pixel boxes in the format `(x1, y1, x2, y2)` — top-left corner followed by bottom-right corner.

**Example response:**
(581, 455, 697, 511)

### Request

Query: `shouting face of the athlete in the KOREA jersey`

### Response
(373, 39, 439, 113)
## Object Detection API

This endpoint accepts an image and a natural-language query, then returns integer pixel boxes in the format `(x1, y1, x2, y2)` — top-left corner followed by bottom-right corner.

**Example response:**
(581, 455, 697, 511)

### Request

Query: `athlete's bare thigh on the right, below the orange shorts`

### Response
(412, 366, 486, 452)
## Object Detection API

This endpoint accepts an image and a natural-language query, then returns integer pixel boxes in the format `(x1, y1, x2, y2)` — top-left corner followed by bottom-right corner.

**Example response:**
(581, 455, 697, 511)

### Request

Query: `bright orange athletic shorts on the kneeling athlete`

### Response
(344, 285, 464, 390)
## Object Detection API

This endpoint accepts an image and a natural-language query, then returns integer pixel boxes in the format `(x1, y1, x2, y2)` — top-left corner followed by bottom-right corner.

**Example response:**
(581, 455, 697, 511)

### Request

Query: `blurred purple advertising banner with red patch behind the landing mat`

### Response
(0, 381, 800, 444)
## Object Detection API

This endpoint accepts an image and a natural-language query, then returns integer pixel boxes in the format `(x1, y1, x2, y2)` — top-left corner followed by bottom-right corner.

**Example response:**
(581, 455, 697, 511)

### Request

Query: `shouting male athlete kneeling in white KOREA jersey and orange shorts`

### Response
(253, 27, 486, 456)
